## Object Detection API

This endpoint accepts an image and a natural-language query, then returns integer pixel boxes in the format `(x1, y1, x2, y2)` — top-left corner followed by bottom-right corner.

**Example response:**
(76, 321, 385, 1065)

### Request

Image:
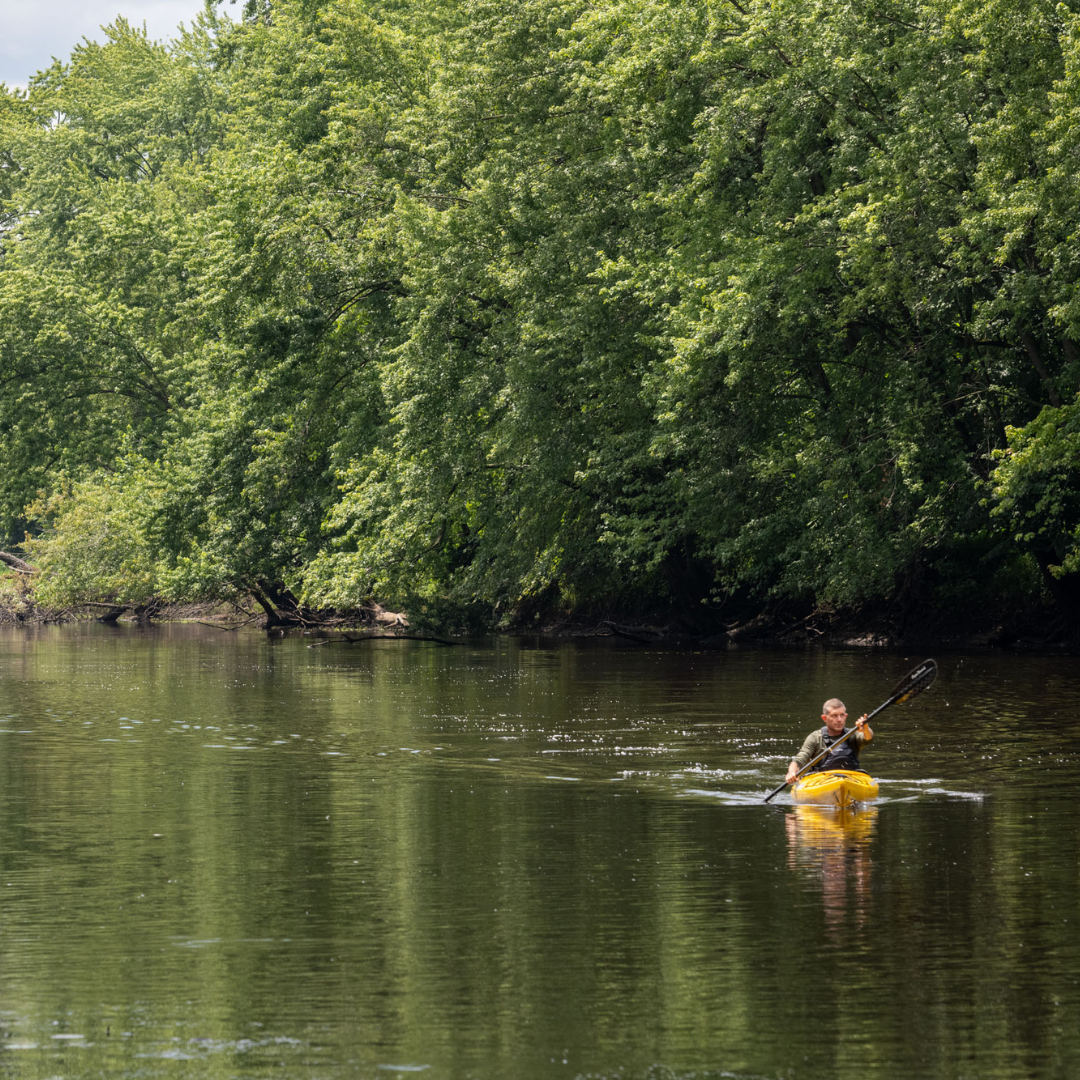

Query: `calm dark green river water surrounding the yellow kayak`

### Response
(0, 625, 1080, 1080)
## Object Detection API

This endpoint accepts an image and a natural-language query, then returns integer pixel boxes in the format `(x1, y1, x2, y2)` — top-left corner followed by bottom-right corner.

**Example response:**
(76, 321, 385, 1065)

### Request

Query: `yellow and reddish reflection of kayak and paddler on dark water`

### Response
(784, 805, 877, 931)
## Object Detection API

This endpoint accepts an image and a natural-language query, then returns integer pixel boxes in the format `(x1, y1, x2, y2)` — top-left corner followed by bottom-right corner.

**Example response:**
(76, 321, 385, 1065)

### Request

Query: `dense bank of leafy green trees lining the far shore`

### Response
(6, 0, 1080, 648)
